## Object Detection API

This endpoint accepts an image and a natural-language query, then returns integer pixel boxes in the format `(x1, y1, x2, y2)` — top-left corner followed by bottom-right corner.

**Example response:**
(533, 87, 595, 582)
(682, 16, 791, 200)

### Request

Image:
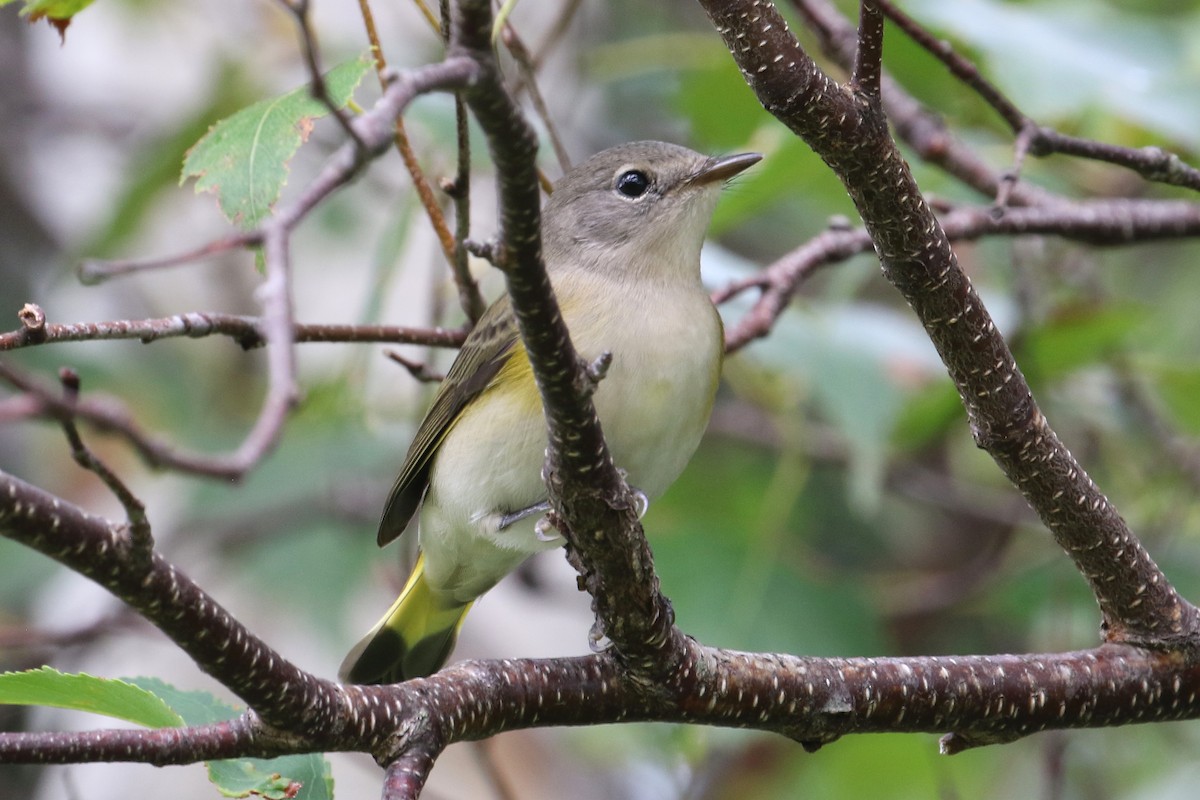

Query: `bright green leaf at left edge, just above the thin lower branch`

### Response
(0, 667, 184, 728)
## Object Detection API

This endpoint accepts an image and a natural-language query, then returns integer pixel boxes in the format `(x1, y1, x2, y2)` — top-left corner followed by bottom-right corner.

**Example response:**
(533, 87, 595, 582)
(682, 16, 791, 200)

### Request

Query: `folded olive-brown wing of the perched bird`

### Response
(377, 295, 518, 547)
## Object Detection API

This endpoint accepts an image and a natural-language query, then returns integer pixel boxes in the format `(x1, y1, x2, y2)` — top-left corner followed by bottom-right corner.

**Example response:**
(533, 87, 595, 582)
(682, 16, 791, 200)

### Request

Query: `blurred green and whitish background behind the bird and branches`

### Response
(0, 0, 1200, 800)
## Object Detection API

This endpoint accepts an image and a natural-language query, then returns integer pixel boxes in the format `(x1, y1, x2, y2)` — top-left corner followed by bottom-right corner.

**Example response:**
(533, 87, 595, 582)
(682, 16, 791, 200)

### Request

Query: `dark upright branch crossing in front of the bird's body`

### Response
(450, 0, 682, 666)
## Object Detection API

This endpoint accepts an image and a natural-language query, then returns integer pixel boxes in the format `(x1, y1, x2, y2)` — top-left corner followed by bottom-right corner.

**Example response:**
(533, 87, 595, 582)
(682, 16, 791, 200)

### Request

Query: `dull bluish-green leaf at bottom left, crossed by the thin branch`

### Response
(130, 678, 334, 800)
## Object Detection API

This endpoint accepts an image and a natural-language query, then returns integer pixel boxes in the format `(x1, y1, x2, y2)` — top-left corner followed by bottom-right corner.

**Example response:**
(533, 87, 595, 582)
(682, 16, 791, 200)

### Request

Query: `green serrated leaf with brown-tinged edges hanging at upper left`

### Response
(179, 54, 372, 229)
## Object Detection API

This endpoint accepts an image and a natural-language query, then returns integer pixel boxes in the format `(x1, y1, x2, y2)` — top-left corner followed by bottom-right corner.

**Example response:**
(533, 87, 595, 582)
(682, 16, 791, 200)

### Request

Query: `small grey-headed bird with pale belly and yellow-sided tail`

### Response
(340, 142, 762, 684)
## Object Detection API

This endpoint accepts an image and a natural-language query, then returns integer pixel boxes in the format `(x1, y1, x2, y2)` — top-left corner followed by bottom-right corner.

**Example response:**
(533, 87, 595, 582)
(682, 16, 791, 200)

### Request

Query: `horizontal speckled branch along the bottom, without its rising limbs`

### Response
(9, 644, 1200, 762)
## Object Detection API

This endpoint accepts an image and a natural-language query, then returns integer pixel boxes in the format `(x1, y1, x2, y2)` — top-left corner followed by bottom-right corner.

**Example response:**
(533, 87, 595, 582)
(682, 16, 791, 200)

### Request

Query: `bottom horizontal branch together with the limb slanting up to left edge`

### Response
(0, 438, 1200, 763)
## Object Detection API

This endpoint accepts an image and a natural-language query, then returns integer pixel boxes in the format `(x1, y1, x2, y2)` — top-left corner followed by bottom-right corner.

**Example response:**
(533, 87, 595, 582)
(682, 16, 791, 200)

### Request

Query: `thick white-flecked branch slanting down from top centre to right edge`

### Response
(701, 0, 1200, 645)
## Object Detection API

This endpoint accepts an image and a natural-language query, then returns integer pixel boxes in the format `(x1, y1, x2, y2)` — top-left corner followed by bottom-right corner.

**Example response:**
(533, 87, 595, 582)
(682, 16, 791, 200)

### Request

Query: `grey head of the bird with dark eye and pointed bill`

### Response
(542, 142, 762, 279)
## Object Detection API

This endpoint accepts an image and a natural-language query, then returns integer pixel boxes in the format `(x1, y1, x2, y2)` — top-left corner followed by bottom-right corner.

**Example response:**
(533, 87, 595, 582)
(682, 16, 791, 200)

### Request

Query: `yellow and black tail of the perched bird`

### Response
(338, 554, 470, 684)
